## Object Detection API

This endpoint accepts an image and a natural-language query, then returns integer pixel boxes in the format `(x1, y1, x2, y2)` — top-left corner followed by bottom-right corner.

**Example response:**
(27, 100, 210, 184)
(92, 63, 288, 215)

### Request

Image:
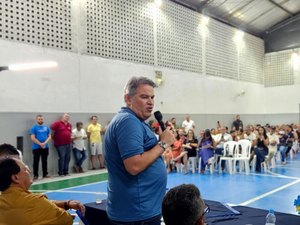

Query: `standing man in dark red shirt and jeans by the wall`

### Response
(51, 113, 72, 176)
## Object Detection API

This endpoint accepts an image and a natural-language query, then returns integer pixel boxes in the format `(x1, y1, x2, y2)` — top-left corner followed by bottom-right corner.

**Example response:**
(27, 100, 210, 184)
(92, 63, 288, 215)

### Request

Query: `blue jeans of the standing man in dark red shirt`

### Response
(55, 144, 71, 175)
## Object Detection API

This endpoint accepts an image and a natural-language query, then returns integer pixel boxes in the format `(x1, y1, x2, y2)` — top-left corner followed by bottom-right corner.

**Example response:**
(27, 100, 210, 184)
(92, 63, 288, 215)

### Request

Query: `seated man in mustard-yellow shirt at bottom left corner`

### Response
(0, 158, 85, 225)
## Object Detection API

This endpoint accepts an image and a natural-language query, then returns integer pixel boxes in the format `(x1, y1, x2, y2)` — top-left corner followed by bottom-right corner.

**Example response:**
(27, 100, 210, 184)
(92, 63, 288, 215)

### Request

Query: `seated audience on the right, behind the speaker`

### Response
(157, 115, 300, 174)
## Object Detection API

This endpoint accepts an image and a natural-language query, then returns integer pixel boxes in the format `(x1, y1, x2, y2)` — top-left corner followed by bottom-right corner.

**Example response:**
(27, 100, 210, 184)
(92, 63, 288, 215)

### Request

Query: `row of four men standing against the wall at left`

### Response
(30, 113, 105, 180)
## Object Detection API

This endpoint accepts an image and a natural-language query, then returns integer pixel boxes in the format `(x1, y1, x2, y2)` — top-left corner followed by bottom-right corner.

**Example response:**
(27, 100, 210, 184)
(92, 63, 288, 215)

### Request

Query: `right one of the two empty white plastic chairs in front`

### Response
(233, 139, 254, 175)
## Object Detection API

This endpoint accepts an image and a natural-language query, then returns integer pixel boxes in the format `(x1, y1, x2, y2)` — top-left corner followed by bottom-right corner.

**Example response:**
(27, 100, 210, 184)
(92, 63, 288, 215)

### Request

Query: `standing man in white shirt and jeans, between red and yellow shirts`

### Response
(71, 122, 87, 173)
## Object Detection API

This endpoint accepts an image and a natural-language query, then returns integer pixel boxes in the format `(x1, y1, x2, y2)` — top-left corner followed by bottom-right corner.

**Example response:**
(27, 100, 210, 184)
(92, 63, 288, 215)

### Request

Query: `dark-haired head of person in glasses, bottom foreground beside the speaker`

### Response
(162, 184, 209, 225)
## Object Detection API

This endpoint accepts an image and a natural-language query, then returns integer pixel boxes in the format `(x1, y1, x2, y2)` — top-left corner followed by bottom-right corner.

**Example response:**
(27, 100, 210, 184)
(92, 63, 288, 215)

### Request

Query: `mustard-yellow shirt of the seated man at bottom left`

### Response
(0, 187, 73, 225)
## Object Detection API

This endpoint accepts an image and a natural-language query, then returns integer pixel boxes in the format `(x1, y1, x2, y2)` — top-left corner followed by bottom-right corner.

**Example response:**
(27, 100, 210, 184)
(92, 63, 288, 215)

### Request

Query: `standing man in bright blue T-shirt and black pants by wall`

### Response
(30, 115, 51, 180)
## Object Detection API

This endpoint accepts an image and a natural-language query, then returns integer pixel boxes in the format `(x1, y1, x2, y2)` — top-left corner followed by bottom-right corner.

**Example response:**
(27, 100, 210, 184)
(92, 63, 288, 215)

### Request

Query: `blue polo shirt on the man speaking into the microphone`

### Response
(104, 107, 167, 222)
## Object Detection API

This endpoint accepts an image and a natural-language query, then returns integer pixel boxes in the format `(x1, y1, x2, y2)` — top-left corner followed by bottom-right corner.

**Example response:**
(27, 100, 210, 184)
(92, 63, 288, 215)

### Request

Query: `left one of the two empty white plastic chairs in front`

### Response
(219, 141, 238, 174)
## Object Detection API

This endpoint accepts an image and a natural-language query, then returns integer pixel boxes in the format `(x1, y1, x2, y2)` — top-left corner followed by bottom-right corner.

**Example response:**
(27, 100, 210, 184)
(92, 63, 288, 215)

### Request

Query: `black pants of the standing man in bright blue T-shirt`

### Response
(32, 148, 49, 177)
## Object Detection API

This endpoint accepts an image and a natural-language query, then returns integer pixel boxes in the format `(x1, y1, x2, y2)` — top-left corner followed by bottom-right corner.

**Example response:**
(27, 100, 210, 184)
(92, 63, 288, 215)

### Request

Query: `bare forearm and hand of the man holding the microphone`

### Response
(123, 128, 175, 175)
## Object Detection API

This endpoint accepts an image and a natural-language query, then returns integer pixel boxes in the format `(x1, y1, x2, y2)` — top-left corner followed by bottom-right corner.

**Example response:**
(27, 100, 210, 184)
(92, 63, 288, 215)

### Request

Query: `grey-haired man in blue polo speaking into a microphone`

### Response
(104, 77, 175, 225)
